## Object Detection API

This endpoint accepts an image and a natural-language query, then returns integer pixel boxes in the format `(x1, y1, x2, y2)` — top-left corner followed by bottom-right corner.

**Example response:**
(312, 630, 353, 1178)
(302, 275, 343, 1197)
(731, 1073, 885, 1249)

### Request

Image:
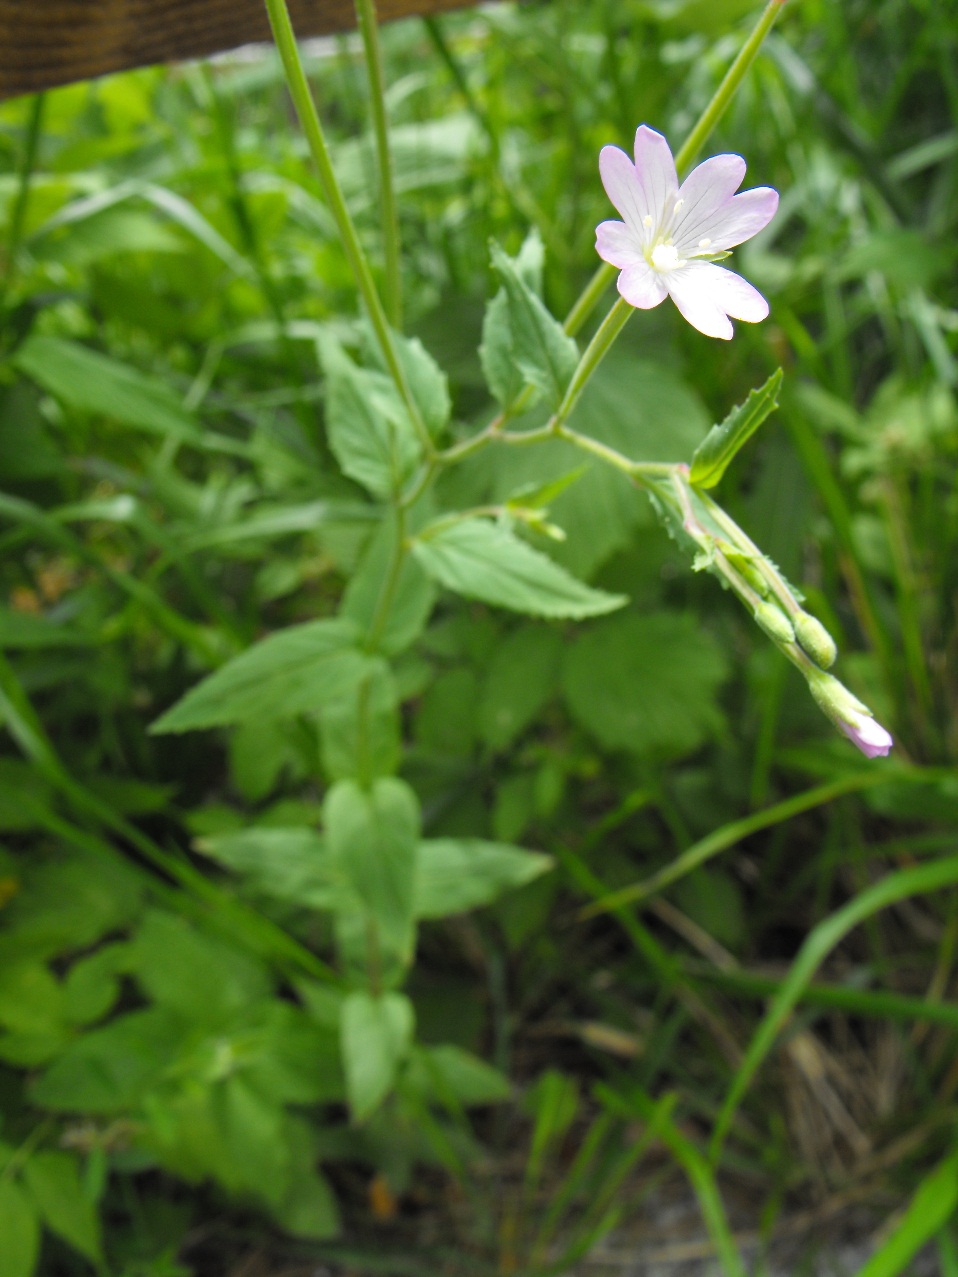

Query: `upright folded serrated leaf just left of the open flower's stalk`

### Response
(480, 234, 579, 407)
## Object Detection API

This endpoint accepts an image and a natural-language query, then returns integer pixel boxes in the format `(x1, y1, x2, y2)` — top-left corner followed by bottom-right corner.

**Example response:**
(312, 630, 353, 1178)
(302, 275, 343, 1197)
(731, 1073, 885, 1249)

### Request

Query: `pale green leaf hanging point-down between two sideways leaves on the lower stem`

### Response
(323, 778, 419, 960)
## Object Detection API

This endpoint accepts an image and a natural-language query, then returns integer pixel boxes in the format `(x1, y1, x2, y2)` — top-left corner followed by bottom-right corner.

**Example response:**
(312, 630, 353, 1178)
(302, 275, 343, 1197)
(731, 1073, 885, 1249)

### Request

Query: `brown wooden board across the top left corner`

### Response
(0, 0, 477, 100)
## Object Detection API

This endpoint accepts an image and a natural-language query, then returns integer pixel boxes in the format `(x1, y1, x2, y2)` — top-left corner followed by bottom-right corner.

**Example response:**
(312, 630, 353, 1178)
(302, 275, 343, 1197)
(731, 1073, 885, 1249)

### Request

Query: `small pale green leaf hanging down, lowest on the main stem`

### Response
(340, 992, 415, 1121)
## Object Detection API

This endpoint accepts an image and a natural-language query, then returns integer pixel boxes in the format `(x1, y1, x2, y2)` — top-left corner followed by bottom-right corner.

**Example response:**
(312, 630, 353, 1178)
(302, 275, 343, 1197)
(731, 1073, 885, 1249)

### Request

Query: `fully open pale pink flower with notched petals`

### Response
(595, 124, 778, 340)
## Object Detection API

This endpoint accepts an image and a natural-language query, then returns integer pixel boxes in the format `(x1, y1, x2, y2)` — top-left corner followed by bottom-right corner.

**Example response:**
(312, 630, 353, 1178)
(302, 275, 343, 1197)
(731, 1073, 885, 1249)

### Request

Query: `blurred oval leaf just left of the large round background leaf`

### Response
(479, 626, 562, 750)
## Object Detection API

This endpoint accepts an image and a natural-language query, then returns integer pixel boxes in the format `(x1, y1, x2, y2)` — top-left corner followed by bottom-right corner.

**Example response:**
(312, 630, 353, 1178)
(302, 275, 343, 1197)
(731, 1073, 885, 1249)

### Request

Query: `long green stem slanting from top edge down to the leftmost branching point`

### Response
(266, 0, 436, 456)
